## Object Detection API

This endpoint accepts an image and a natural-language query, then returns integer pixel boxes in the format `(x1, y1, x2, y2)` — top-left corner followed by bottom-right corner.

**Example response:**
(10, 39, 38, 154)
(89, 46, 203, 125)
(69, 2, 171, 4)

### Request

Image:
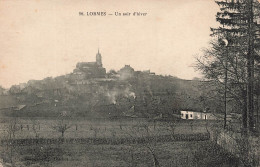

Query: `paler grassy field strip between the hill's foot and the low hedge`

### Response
(0, 118, 212, 139)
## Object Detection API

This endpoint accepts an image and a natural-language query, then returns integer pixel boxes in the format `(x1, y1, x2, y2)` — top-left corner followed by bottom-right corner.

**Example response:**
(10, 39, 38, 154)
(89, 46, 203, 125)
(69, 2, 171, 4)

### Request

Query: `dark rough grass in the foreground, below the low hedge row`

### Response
(1, 141, 238, 167)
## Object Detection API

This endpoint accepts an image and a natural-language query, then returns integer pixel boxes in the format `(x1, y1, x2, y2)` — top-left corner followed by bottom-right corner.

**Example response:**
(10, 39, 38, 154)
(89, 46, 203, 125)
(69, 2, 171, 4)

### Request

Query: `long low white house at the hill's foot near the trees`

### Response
(181, 111, 217, 120)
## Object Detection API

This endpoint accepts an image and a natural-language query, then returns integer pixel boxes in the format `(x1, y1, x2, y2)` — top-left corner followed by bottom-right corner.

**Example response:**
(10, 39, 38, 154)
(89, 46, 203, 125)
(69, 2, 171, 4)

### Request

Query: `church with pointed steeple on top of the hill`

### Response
(73, 49, 106, 80)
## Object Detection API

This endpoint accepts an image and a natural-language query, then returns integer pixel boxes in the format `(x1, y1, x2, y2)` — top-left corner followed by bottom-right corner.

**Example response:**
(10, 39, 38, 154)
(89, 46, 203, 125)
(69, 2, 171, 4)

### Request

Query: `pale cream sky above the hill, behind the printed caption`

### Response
(0, 0, 218, 88)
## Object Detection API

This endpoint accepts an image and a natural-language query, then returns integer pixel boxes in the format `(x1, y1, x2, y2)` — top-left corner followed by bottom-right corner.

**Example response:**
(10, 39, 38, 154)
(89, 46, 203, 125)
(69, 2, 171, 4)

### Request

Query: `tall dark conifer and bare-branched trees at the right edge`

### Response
(196, 0, 260, 134)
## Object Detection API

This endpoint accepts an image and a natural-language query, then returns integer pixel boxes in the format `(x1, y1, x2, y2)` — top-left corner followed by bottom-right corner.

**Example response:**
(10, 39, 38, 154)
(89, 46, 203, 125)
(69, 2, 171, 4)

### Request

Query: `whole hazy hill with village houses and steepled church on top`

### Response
(0, 50, 215, 118)
